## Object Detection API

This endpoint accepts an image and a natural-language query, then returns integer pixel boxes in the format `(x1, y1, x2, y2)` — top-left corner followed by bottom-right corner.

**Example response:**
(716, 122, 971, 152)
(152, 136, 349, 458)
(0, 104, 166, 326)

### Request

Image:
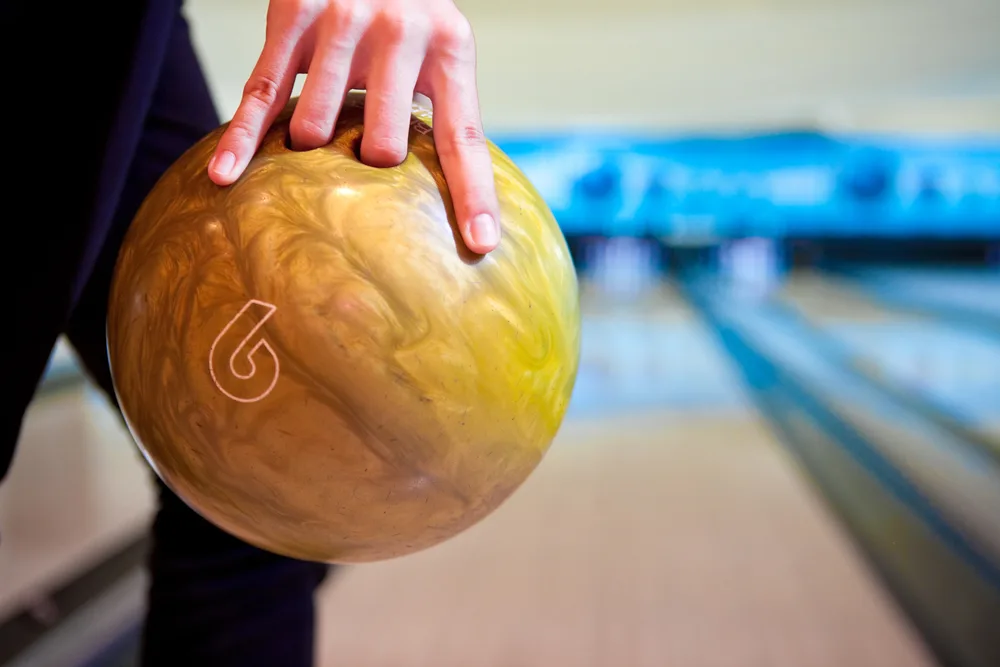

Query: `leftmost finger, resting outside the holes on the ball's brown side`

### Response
(208, 40, 298, 185)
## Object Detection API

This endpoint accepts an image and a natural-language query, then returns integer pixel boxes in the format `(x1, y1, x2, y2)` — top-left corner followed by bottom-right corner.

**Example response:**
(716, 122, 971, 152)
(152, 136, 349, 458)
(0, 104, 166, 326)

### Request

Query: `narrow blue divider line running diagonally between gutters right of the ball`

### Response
(687, 285, 1000, 591)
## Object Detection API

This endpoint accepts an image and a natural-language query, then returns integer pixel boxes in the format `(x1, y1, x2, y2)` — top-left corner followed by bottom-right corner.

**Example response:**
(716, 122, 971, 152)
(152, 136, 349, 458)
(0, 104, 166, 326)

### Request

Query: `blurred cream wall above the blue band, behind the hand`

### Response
(188, 0, 1000, 131)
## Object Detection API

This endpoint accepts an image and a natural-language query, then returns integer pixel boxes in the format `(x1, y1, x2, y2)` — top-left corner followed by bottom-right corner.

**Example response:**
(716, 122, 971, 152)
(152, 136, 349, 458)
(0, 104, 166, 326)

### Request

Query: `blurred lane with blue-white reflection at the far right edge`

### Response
(779, 272, 1000, 440)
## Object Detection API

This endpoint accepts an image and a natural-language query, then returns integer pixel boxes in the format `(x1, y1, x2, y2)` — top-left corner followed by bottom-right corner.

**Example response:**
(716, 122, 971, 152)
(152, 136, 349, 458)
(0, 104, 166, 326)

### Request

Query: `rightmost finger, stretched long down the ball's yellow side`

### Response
(430, 20, 500, 254)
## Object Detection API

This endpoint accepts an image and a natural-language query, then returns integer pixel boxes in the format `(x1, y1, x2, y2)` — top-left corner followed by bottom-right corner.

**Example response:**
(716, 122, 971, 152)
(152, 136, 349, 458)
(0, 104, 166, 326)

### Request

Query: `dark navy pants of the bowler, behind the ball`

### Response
(0, 9, 327, 667)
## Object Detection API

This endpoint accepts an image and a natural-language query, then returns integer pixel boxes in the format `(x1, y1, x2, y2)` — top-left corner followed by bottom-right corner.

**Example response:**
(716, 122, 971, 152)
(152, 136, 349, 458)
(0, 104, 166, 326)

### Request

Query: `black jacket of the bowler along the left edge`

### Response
(0, 0, 188, 478)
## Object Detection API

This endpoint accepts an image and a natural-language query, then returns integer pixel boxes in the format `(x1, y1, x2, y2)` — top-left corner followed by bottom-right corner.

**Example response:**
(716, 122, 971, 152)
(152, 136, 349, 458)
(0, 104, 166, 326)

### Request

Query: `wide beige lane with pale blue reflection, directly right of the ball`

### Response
(320, 285, 933, 667)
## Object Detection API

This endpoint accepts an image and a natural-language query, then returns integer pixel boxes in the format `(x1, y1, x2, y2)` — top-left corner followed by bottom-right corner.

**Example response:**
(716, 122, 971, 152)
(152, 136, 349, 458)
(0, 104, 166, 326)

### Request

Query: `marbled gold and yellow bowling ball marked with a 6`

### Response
(107, 92, 580, 562)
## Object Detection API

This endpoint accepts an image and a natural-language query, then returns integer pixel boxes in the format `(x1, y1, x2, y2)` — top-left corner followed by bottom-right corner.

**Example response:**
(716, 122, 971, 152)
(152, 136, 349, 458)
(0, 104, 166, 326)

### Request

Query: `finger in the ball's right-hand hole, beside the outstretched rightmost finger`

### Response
(361, 19, 429, 167)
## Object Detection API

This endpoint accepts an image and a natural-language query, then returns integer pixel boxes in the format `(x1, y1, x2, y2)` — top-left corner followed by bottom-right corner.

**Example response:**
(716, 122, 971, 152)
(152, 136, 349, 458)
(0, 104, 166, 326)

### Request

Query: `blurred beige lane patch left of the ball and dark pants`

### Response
(0, 384, 154, 619)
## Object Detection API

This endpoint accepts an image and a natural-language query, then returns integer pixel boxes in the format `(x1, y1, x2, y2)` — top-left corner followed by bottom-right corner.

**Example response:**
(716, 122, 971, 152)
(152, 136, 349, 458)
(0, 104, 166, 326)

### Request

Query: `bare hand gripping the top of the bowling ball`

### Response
(209, 0, 500, 253)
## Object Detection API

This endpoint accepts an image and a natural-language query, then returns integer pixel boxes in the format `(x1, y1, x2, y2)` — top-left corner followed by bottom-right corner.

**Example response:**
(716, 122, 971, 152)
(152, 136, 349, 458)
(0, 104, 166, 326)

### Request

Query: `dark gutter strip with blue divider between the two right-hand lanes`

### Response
(691, 277, 1000, 667)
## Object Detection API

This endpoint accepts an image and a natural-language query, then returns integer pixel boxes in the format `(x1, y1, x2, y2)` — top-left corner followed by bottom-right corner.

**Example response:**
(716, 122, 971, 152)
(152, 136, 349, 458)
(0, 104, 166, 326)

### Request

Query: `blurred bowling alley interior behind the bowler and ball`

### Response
(0, 0, 1000, 667)
